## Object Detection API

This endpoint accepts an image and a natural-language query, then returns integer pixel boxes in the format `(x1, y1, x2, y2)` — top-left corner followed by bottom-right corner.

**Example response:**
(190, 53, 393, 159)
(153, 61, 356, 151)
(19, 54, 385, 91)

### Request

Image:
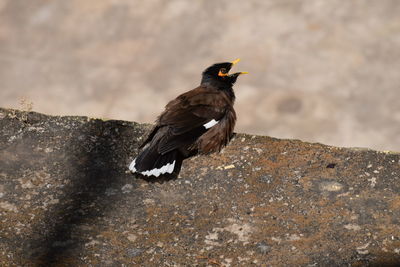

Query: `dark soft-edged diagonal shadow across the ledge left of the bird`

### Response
(27, 120, 134, 266)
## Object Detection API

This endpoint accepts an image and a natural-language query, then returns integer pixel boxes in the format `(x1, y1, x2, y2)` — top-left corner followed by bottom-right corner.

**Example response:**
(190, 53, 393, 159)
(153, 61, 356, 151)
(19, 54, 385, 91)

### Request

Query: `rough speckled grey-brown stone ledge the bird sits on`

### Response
(0, 109, 400, 266)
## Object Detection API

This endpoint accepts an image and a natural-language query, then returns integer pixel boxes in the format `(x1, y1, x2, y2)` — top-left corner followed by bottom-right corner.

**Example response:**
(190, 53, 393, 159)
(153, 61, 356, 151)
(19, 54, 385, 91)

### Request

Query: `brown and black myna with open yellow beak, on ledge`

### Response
(129, 59, 248, 177)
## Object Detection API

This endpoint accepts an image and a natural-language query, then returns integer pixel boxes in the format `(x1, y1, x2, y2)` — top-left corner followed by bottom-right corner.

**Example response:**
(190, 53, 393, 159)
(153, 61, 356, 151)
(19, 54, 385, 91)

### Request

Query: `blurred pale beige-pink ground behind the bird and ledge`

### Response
(0, 0, 400, 151)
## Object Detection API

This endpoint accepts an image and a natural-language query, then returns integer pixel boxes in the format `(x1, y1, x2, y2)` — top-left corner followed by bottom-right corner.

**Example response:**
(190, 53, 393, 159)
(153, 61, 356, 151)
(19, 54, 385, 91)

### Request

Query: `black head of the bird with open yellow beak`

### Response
(201, 58, 248, 88)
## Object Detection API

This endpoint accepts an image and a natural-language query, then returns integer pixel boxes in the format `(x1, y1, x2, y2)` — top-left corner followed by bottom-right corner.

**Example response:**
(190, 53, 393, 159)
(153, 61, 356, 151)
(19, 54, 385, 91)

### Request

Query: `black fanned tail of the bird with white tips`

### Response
(129, 146, 183, 177)
